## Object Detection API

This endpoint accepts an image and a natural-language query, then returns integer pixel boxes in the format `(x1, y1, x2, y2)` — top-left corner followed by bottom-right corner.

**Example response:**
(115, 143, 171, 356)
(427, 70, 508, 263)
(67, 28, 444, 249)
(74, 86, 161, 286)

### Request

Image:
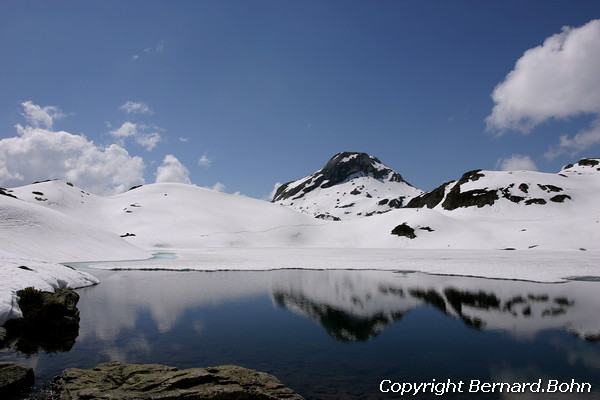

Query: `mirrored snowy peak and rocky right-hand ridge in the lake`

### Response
(272, 271, 600, 341)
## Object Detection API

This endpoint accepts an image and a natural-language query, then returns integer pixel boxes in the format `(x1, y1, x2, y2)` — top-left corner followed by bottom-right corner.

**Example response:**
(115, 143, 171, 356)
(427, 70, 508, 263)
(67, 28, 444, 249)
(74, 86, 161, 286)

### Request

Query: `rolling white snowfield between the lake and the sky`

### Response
(0, 160, 600, 323)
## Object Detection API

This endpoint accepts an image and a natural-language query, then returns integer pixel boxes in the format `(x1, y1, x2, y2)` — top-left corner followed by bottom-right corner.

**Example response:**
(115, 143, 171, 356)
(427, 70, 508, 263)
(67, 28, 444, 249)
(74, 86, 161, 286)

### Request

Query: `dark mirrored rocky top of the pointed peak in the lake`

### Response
(273, 291, 403, 342)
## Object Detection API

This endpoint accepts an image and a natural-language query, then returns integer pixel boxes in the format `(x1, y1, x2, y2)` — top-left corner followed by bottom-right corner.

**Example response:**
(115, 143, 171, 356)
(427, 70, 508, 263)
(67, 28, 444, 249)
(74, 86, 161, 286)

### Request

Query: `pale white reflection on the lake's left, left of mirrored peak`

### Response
(79, 270, 268, 342)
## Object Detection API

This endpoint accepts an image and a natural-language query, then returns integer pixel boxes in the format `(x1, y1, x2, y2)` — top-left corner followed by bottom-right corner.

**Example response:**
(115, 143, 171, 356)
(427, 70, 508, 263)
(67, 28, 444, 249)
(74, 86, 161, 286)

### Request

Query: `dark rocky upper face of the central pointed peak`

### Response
(272, 151, 406, 202)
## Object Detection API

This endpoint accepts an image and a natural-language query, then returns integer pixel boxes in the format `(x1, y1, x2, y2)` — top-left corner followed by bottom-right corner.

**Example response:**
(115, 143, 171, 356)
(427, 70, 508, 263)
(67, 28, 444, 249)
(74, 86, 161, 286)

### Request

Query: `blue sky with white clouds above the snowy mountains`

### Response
(0, 0, 600, 200)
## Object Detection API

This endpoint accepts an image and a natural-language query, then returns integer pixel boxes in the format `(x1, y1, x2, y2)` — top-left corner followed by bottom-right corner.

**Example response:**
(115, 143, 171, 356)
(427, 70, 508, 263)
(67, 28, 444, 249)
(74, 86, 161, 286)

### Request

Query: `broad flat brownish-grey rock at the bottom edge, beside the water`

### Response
(54, 362, 302, 400)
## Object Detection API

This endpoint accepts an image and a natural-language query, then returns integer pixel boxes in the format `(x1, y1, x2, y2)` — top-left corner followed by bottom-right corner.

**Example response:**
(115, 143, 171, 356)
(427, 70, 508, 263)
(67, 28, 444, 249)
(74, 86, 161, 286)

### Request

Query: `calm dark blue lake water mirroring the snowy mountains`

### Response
(0, 269, 600, 400)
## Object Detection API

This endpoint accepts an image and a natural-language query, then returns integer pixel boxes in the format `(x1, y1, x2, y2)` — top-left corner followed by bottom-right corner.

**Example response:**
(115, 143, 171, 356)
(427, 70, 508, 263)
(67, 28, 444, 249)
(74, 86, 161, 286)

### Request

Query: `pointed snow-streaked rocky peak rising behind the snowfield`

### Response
(272, 152, 423, 221)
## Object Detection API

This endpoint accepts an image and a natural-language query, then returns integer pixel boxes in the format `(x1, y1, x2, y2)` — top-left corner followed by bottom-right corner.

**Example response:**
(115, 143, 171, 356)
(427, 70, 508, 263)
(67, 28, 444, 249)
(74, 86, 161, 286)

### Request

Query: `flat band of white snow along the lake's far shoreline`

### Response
(85, 247, 600, 282)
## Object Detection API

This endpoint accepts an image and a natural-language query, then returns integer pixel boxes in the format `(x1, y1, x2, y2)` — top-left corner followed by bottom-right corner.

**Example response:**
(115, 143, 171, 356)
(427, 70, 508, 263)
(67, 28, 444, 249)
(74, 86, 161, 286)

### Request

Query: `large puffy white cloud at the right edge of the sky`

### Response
(486, 19, 600, 158)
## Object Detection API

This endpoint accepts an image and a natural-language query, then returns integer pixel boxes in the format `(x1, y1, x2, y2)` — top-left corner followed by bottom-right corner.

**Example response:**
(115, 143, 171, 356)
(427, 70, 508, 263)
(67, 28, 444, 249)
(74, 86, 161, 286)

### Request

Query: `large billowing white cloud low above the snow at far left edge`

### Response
(0, 125, 144, 194)
